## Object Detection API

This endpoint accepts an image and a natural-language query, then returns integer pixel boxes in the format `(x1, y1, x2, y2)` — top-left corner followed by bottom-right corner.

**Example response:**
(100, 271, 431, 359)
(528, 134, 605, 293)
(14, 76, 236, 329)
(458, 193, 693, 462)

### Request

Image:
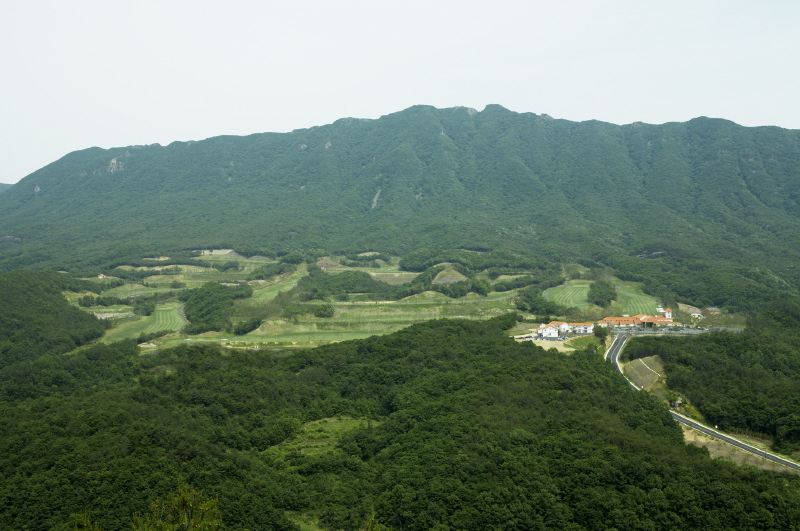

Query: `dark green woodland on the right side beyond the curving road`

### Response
(625, 300, 800, 453)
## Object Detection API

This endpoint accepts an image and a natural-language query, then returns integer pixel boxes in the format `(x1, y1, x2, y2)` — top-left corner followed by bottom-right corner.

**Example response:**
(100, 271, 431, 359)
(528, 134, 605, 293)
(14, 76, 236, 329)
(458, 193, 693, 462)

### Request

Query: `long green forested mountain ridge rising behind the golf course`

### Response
(0, 105, 800, 296)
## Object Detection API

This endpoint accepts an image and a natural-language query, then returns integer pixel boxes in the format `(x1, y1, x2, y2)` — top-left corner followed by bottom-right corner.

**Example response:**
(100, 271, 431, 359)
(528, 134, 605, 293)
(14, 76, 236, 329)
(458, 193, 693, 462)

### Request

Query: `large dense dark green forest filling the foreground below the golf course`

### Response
(0, 315, 800, 531)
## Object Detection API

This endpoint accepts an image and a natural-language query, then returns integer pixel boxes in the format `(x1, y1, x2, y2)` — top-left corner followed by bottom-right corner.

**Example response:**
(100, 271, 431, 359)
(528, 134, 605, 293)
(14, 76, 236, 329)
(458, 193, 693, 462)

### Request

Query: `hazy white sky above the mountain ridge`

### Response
(0, 0, 800, 183)
